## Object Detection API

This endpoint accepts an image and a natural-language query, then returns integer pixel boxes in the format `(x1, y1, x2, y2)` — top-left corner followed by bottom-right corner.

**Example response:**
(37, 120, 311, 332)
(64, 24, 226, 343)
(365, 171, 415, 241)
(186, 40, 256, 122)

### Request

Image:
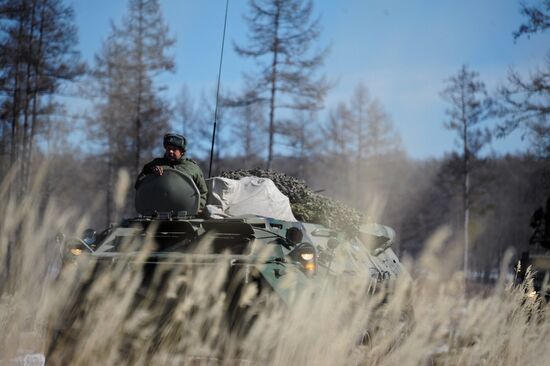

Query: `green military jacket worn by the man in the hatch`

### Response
(135, 157, 208, 209)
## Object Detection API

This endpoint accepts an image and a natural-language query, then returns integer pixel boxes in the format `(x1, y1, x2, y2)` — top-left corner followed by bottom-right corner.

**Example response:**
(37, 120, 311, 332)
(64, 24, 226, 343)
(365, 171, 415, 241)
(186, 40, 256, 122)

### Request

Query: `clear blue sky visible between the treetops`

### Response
(72, 0, 550, 158)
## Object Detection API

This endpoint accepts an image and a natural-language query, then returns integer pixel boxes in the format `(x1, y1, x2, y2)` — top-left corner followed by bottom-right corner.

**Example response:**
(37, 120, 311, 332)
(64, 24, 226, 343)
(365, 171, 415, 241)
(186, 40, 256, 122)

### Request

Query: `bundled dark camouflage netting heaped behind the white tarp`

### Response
(221, 168, 361, 234)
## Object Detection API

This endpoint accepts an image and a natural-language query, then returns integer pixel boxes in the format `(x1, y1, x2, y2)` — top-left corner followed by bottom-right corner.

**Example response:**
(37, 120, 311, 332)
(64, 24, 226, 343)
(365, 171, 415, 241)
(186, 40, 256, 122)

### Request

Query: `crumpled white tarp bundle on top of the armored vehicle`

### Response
(206, 177, 296, 221)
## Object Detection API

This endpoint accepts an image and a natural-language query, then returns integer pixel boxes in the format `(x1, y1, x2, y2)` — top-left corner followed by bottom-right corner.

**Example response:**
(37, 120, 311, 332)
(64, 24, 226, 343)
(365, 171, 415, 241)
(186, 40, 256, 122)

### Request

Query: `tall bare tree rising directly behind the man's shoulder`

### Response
(112, 0, 175, 174)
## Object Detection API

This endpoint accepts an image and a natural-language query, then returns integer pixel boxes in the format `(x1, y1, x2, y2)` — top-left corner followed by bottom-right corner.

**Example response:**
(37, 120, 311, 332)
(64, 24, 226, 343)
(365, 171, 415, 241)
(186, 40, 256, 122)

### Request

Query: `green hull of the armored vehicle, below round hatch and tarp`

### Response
(69, 215, 408, 305)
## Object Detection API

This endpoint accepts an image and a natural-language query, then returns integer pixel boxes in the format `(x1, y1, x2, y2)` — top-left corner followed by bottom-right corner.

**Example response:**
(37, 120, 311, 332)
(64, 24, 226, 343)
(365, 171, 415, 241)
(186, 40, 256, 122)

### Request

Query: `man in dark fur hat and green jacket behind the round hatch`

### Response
(135, 133, 208, 209)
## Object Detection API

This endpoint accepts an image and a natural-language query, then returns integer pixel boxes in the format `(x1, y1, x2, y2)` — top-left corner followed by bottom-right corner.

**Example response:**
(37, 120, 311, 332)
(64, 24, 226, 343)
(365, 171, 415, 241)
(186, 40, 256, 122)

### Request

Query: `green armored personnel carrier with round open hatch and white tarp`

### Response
(64, 168, 408, 305)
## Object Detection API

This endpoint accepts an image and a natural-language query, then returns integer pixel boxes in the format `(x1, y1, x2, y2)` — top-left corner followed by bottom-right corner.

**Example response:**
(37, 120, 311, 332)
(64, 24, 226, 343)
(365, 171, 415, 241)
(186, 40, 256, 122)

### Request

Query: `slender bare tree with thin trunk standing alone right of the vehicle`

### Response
(441, 65, 491, 275)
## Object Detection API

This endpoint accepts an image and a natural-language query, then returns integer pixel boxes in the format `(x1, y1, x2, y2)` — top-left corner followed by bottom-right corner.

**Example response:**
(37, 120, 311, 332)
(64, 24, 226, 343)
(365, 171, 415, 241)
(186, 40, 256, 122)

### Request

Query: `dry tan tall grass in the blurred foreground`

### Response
(0, 168, 550, 365)
